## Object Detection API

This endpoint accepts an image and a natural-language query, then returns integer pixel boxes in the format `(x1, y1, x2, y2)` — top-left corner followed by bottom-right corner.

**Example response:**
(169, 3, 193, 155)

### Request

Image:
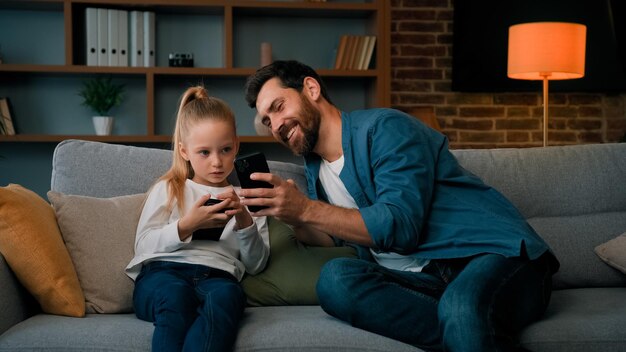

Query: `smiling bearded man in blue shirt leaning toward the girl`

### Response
(242, 61, 558, 351)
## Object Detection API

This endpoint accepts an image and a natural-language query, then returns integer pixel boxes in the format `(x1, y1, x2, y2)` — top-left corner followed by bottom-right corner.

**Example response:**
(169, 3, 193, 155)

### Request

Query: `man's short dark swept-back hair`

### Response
(245, 60, 332, 108)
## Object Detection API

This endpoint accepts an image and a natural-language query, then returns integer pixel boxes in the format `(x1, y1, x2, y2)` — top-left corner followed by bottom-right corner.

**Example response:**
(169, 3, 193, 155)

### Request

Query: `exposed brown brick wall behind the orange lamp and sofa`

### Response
(391, 0, 626, 148)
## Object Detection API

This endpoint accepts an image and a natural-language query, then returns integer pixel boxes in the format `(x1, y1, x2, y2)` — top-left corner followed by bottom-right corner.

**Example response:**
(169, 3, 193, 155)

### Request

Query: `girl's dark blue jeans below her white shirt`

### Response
(133, 261, 246, 351)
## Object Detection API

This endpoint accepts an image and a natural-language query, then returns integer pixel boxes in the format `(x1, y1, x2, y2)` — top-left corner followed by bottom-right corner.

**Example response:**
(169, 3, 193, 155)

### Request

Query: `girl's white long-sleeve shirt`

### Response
(126, 180, 269, 280)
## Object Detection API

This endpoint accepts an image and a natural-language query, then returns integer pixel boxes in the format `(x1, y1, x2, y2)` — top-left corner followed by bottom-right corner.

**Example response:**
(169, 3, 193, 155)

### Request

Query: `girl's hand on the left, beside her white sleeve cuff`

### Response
(178, 194, 232, 240)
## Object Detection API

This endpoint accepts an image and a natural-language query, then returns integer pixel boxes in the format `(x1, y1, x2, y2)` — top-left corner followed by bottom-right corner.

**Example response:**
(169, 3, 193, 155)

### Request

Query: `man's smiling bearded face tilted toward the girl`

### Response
(256, 78, 321, 155)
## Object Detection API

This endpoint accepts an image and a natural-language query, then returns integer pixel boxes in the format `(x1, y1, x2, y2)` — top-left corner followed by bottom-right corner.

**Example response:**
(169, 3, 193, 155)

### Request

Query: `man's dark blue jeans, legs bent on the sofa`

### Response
(317, 253, 553, 352)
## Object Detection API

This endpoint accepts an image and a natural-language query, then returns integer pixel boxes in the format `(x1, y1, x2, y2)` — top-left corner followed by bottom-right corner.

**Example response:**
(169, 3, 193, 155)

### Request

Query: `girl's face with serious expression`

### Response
(180, 119, 239, 187)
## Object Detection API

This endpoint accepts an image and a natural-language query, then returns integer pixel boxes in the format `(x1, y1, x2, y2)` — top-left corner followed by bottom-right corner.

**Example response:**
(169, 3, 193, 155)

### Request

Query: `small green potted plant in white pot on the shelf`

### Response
(78, 77, 124, 136)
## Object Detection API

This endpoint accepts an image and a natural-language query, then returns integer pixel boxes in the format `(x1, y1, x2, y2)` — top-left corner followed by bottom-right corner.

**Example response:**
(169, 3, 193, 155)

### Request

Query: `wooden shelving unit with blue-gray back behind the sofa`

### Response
(0, 0, 391, 143)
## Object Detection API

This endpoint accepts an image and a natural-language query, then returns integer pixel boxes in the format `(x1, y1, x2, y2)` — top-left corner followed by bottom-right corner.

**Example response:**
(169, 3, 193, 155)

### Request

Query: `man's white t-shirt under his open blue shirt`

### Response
(319, 155, 428, 272)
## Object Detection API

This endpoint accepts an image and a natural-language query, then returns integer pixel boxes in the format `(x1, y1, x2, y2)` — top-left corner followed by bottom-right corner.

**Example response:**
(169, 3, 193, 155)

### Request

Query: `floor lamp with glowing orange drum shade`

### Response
(508, 22, 587, 147)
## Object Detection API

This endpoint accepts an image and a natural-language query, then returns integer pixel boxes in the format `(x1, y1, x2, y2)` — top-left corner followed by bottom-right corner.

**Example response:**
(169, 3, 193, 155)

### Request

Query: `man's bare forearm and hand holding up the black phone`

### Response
(241, 173, 373, 247)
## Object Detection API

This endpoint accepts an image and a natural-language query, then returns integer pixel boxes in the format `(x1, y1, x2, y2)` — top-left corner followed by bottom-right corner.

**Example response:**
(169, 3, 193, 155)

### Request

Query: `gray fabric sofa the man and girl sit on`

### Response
(0, 140, 626, 352)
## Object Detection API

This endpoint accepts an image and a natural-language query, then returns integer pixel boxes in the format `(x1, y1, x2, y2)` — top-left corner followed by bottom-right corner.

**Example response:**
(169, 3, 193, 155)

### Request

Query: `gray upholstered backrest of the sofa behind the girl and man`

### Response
(51, 140, 626, 288)
